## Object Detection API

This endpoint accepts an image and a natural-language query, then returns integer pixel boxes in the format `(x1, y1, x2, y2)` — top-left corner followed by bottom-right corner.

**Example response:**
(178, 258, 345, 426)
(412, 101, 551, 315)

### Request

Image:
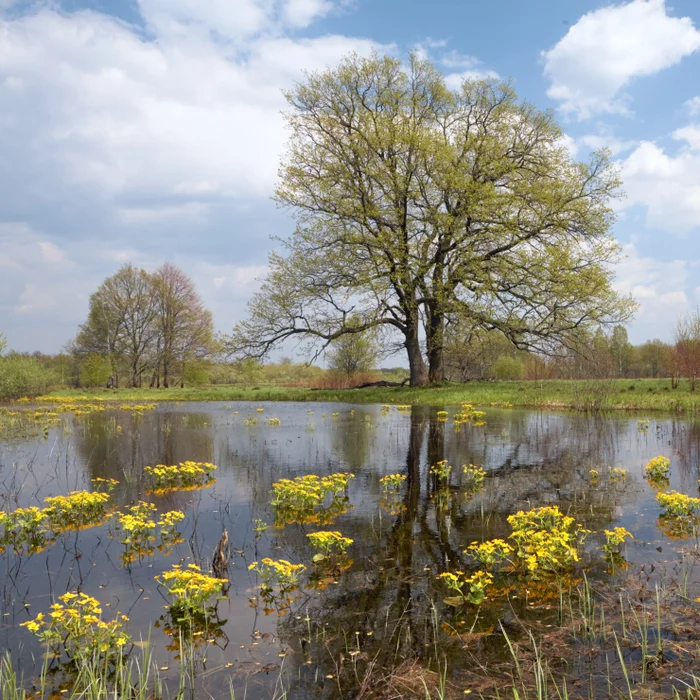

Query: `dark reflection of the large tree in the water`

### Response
(278, 408, 636, 692)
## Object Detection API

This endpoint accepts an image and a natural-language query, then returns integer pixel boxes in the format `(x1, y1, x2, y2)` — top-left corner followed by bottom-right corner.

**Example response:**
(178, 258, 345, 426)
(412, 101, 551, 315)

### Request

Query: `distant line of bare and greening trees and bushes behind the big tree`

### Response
(0, 263, 700, 399)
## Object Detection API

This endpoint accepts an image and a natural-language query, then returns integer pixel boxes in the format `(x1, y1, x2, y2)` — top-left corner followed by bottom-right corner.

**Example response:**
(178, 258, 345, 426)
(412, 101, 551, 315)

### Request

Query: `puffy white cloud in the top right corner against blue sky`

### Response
(543, 0, 700, 119)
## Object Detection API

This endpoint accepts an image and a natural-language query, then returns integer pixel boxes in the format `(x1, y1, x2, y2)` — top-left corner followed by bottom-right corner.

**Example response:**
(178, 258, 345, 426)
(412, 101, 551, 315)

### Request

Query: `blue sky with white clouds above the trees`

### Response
(0, 0, 700, 352)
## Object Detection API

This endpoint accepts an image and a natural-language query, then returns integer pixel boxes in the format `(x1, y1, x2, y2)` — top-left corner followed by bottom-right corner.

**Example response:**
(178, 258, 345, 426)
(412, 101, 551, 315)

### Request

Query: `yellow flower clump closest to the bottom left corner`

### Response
(22, 592, 131, 661)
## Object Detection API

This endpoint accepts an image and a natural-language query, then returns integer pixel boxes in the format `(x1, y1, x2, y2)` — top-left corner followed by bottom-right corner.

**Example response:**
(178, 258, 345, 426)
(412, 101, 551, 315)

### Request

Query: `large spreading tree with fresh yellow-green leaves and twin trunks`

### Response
(230, 55, 633, 385)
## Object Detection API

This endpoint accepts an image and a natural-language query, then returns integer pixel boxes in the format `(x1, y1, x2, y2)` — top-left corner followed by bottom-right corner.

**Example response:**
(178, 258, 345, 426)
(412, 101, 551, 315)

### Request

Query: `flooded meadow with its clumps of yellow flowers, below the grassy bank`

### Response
(0, 403, 700, 700)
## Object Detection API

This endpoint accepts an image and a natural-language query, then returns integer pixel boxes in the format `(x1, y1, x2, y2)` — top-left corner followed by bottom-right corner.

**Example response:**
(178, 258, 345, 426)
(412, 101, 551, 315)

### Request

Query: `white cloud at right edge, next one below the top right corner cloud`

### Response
(620, 139, 700, 234)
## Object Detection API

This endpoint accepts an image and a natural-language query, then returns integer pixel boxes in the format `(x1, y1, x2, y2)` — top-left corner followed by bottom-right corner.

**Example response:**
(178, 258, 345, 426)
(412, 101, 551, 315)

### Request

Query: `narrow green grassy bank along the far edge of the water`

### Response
(19, 379, 700, 413)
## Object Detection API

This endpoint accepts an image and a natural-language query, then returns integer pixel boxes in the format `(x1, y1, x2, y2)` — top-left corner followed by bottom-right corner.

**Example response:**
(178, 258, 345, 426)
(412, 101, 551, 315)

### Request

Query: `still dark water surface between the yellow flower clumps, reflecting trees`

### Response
(0, 403, 700, 700)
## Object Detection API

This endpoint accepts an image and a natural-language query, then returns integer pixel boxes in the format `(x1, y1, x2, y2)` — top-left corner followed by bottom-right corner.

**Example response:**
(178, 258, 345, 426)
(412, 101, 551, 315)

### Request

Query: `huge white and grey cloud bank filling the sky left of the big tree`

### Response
(0, 0, 394, 350)
